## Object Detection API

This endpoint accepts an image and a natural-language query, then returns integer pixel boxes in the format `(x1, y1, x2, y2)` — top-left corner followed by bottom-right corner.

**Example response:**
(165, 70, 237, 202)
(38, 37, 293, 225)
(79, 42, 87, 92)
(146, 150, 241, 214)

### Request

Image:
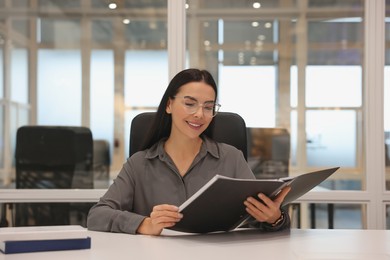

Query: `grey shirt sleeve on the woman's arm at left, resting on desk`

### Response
(87, 155, 145, 234)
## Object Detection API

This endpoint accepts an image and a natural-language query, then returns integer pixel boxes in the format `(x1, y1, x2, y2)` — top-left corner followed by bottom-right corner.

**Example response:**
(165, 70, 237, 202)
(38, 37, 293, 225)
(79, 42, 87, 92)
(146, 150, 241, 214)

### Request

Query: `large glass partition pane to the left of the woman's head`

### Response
(0, 0, 168, 188)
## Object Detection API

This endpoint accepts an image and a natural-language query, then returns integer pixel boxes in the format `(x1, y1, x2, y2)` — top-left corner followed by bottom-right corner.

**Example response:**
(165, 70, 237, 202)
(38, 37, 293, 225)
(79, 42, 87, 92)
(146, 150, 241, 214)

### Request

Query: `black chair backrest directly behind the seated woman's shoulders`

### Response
(129, 112, 247, 159)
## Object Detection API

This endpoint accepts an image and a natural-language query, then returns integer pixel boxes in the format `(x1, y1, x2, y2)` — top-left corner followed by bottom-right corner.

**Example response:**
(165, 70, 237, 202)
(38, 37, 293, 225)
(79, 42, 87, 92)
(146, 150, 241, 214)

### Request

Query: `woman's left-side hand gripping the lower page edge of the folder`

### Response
(137, 204, 183, 236)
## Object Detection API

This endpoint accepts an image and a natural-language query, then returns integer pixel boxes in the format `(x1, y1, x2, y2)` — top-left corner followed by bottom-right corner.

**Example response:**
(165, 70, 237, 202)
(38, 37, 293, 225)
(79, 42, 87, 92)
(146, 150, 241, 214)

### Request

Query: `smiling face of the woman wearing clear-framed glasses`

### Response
(166, 82, 215, 139)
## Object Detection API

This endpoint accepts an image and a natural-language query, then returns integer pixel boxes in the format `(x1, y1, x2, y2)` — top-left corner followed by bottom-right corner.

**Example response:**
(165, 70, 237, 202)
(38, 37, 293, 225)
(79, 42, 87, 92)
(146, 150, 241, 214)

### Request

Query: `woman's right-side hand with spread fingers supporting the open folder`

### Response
(244, 187, 291, 224)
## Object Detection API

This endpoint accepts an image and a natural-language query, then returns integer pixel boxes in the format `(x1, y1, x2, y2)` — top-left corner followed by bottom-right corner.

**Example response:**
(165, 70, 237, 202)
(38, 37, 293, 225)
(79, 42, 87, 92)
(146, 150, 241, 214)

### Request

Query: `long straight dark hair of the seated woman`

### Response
(141, 69, 218, 150)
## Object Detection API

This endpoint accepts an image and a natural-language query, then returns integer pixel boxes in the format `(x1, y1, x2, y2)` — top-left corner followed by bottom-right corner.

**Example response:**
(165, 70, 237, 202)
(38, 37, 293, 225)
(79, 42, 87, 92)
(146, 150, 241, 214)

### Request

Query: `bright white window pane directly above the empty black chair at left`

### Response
(37, 49, 82, 126)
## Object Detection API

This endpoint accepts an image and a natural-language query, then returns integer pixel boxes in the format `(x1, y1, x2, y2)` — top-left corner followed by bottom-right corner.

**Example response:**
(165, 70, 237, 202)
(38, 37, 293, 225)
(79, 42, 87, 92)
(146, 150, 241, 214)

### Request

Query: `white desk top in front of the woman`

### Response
(0, 229, 390, 260)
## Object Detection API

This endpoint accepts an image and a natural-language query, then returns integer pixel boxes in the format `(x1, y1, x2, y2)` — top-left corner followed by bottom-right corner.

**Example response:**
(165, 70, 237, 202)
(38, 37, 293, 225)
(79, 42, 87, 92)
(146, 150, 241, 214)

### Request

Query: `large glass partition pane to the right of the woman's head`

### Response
(186, 0, 364, 190)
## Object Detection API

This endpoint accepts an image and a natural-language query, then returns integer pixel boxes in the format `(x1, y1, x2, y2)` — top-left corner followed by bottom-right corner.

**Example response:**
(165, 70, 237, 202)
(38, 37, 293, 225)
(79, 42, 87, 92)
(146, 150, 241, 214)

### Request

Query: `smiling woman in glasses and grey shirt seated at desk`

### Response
(87, 69, 290, 235)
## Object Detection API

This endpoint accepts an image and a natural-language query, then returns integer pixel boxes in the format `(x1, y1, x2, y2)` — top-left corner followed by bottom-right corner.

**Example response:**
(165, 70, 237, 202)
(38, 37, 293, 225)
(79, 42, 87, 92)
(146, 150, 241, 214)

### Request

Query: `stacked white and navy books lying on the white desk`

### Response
(0, 225, 91, 254)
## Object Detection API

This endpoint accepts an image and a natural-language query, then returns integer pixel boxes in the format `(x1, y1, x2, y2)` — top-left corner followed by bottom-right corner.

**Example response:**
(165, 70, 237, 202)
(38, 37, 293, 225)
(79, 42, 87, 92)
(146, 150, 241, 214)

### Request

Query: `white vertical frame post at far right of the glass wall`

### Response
(363, 0, 385, 229)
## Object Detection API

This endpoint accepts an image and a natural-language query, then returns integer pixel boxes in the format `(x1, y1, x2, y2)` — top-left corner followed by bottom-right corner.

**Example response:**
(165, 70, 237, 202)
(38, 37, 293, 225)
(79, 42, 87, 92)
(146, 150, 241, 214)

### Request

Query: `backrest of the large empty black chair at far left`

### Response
(15, 126, 93, 189)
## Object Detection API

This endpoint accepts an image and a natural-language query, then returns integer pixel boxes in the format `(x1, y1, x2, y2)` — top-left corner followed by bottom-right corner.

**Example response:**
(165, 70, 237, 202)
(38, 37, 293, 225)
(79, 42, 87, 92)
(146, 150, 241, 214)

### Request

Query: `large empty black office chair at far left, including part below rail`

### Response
(14, 126, 93, 226)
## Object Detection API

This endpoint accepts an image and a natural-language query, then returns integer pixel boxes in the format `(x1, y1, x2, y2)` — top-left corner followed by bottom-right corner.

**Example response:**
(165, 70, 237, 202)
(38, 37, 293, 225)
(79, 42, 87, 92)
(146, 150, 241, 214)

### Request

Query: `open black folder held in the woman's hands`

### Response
(170, 167, 339, 233)
